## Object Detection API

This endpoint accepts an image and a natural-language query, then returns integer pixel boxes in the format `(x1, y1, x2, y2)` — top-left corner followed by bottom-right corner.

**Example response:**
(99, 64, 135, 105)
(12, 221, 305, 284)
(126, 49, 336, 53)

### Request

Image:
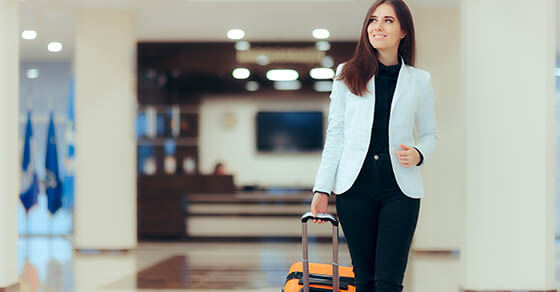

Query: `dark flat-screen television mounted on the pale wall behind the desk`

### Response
(256, 111, 323, 152)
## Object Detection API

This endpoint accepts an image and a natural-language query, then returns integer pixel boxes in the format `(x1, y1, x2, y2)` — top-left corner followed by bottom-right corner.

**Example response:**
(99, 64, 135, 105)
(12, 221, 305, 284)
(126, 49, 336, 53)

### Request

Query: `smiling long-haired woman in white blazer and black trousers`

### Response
(311, 0, 438, 292)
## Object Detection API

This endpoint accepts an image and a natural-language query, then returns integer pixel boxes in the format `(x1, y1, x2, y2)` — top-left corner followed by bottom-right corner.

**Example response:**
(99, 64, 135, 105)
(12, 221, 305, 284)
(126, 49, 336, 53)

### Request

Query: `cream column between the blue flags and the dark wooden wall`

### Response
(74, 9, 137, 250)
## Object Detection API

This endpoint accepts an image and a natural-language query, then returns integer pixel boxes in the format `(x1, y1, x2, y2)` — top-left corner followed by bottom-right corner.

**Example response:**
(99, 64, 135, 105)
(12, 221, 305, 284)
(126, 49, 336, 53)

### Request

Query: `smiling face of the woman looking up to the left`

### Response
(367, 3, 405, 50)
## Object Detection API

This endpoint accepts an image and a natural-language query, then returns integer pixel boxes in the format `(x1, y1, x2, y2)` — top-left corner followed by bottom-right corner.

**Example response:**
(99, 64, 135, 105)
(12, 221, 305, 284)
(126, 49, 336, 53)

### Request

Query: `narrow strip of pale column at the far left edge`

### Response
(0, 0, 21, 291)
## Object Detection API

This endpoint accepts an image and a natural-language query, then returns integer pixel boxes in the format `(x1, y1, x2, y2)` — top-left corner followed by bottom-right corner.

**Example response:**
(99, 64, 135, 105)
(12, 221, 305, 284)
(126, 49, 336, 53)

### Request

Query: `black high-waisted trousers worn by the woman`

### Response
(336, 152, 420, 292)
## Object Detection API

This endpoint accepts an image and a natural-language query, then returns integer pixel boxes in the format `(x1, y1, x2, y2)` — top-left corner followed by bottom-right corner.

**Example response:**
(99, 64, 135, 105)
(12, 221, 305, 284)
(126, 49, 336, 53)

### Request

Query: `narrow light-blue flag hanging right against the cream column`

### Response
(62, 80, 74, 210)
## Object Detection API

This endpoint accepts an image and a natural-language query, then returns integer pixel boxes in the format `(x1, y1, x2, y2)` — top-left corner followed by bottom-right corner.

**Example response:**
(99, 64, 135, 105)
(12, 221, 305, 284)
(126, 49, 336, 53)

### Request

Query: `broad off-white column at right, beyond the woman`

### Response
(460, 0, 556, 291)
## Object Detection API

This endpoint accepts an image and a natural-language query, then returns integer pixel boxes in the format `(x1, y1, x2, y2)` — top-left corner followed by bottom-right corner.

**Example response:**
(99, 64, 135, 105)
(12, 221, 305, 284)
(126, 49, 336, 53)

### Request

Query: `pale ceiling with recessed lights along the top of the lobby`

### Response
(20, 0, 474, 62)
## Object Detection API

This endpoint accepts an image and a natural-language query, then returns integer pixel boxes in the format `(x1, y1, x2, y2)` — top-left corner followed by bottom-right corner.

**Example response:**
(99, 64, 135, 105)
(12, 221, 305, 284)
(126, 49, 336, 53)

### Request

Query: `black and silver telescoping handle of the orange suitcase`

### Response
(301, 211, 340, 292)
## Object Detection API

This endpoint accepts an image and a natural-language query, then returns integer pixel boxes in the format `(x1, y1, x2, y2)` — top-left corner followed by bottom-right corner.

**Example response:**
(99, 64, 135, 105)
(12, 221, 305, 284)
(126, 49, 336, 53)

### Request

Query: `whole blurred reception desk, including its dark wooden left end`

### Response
(138, 175, 342, 241)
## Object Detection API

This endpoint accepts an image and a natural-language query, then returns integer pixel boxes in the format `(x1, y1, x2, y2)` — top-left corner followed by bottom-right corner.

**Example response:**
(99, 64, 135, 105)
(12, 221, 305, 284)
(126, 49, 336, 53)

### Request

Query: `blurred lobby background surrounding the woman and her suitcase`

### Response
(0, 0, 560, 292)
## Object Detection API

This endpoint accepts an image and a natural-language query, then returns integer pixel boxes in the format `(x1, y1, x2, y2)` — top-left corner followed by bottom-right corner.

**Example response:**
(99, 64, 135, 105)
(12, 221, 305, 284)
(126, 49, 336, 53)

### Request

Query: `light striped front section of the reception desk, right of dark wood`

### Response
(185, 191, 342, 241)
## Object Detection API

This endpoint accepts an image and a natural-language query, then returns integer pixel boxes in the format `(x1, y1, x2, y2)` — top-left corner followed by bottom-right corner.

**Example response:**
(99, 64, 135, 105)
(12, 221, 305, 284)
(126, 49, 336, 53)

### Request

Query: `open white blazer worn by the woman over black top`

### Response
(313, 57, 438, 198)
